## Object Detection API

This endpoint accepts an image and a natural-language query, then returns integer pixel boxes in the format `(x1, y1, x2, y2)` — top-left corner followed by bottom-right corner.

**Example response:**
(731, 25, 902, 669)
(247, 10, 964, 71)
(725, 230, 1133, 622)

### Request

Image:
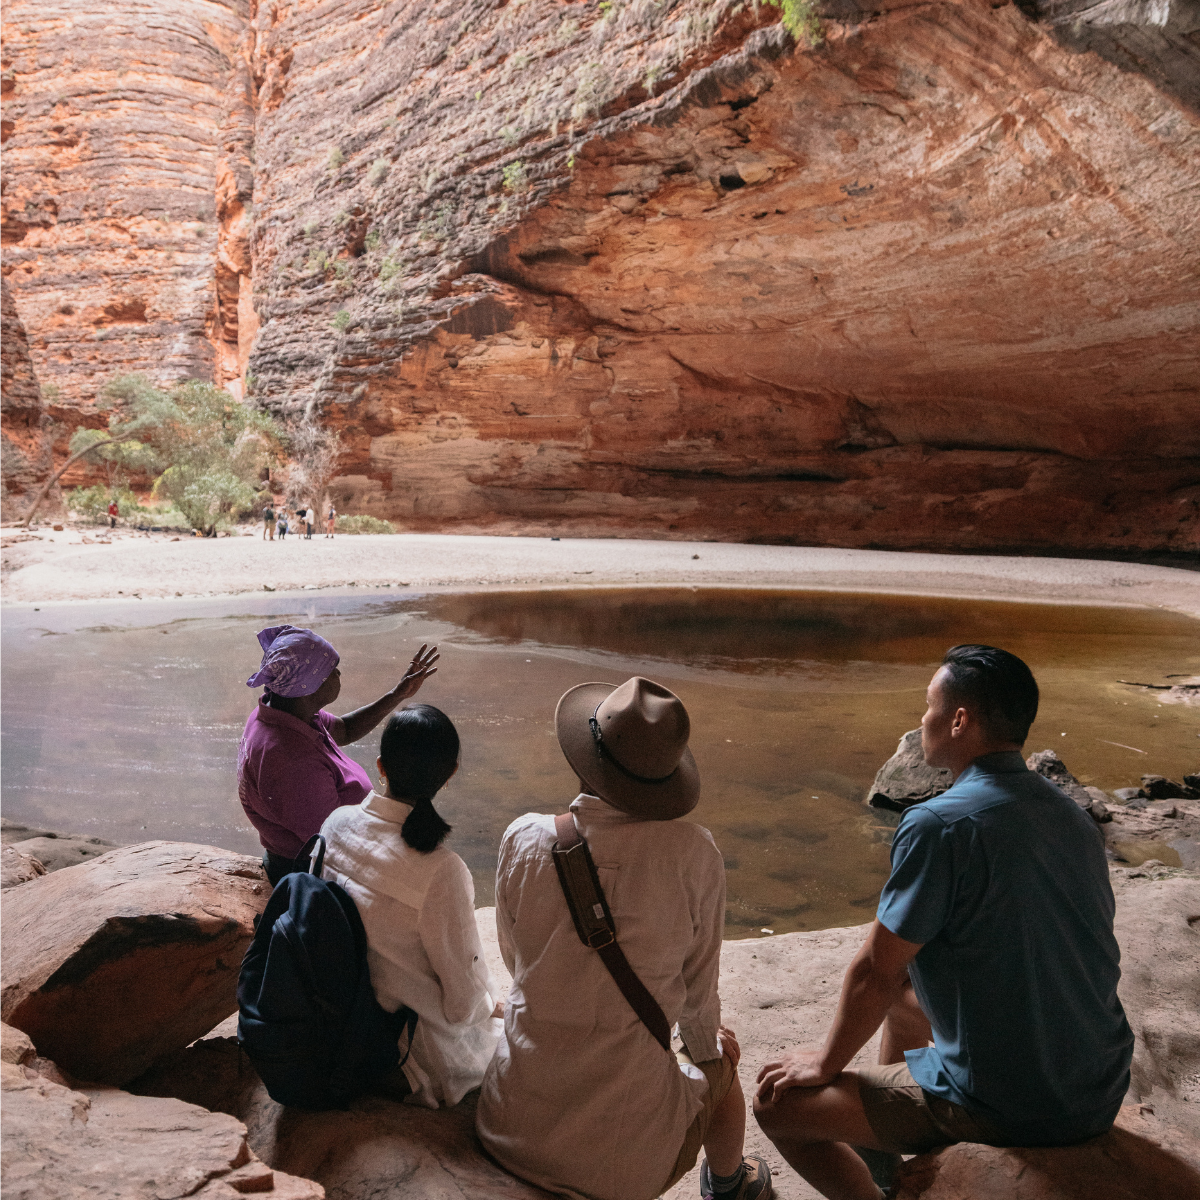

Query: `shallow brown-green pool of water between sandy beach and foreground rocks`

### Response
(2, 588, 1200, 937)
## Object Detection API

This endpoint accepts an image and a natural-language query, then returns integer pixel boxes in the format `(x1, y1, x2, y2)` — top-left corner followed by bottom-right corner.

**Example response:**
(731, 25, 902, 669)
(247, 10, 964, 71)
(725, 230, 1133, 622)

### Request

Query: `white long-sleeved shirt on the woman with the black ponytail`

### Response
(320, 792, 500, 1109)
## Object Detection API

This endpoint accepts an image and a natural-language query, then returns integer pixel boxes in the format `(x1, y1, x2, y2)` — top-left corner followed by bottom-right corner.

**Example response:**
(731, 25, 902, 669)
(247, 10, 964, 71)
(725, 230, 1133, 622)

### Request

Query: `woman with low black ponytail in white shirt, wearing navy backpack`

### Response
(320, 704, 504, 1109)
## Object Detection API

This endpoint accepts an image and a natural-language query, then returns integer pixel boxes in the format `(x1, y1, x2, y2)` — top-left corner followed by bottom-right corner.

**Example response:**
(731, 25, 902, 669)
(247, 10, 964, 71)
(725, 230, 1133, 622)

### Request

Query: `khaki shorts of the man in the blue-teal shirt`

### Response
(853, 1062, 1007, 1154)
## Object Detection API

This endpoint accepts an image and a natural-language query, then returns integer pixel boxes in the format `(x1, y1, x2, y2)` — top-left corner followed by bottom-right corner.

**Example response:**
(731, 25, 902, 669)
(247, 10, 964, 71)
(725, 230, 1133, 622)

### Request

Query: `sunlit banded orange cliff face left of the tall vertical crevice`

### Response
(2, 0, 252, 485)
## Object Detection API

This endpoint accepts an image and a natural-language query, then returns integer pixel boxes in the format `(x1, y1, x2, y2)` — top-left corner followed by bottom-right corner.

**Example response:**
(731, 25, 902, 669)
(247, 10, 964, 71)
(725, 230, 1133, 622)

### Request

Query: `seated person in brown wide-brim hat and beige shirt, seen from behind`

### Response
(476, 678, 772, 1200)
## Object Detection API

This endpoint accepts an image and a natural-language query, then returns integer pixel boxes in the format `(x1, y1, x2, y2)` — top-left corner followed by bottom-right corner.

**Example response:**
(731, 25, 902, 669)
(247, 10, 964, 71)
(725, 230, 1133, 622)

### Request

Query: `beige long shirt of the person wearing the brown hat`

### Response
(476, 794, 725, 1200)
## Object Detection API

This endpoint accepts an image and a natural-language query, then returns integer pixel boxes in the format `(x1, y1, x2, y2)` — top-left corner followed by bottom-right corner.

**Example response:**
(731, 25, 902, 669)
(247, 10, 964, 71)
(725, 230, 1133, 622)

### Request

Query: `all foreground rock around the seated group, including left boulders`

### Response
(0, 842, 1200, 1200)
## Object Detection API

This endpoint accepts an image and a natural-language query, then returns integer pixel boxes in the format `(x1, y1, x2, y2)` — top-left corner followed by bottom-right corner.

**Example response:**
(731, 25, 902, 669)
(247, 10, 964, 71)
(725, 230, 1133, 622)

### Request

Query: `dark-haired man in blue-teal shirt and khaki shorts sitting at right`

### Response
(755, 646, 1133, 1200)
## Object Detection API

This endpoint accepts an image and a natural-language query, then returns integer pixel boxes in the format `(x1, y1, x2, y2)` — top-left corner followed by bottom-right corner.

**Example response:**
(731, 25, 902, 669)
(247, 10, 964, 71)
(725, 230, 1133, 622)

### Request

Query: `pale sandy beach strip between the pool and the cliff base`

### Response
(0, 526, 1200, 617)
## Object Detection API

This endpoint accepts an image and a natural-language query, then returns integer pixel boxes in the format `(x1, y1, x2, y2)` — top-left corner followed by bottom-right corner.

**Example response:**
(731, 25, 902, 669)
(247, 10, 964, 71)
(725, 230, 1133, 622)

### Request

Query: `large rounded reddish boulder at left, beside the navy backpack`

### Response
(0, 841, 270, 1084)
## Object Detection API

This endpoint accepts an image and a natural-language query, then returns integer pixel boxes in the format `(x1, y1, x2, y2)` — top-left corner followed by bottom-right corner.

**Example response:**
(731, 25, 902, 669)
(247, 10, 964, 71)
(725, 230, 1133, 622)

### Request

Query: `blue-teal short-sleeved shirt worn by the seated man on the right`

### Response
(878, 751, 1133, 1146)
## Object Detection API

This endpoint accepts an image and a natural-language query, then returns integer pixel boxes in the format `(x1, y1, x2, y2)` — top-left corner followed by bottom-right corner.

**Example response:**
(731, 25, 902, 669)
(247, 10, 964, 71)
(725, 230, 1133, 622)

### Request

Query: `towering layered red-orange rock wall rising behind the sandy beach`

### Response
(4, 0, 1200, 553)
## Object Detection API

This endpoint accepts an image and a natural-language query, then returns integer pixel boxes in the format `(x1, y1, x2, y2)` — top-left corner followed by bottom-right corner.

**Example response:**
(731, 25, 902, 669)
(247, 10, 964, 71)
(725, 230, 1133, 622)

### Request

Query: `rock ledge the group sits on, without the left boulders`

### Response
(131, 871, 1200, 1200)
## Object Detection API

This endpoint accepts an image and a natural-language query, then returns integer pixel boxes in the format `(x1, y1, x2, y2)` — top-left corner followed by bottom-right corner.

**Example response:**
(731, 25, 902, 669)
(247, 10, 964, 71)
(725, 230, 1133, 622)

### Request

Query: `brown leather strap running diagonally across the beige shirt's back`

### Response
(553, 812, 671, 1054)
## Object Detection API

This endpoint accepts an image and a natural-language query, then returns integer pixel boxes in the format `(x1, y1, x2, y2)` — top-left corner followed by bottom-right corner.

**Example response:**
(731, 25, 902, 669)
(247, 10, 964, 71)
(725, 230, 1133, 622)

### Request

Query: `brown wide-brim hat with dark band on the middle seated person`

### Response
(554, 676, 700, 821)
